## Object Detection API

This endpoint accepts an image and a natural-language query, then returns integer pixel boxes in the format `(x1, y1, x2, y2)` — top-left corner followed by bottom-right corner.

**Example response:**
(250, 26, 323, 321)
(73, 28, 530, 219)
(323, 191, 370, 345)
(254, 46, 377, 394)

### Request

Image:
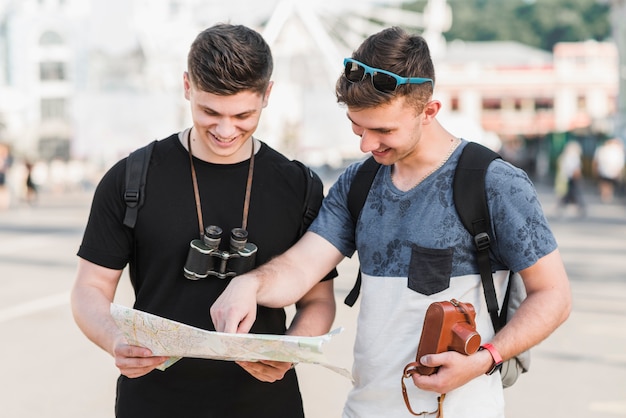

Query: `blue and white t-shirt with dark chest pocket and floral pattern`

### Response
(309, 141, 557, 418)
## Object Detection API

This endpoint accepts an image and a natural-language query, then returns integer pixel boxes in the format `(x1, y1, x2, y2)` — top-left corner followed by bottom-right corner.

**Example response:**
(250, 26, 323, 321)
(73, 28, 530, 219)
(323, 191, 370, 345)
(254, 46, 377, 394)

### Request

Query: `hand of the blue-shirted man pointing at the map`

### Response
(210, 274, 258, 333)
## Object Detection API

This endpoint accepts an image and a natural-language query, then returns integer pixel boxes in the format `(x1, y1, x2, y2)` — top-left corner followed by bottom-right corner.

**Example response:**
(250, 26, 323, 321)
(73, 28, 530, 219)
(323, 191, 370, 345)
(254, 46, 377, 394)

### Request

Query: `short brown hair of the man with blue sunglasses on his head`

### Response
(335, 27, 435, 112)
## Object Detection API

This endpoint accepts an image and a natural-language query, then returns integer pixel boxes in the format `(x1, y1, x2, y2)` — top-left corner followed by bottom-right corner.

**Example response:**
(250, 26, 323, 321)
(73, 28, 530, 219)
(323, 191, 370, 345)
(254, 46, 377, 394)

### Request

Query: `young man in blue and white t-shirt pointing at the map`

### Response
(211, 28, 571, 418)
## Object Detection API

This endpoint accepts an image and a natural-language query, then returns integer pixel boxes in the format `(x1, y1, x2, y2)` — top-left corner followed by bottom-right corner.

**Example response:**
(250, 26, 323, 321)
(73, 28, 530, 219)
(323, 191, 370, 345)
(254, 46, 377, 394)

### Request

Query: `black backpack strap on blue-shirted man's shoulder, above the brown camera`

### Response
(452, 142, 504, 332)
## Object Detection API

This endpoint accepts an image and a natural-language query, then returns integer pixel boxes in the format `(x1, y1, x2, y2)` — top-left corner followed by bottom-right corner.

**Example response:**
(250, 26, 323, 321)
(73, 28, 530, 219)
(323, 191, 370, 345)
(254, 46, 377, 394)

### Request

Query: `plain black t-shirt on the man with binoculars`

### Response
(78, 134, 336, 417)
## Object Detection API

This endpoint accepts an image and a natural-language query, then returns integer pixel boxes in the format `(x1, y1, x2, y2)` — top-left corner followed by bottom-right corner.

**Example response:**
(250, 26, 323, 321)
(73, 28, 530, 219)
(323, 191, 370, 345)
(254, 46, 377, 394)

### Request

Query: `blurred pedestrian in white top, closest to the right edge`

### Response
(593, 138, 625, 203)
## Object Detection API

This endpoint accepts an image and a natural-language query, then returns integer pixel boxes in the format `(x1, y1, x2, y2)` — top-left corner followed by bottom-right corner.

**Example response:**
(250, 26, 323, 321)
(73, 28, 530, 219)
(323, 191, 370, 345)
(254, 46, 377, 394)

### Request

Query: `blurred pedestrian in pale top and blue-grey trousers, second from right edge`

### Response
(555, 141, 587, 216)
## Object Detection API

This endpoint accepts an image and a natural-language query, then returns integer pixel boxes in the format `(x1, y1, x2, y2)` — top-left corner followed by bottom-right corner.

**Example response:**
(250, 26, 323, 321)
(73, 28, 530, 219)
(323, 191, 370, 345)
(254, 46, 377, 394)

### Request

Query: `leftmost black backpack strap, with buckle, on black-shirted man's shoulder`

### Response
(124, 141, 157, 228)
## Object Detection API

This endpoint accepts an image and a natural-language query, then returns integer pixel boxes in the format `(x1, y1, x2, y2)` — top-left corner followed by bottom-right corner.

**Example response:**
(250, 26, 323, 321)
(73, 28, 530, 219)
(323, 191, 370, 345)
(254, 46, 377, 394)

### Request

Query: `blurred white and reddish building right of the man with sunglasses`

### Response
(436, 41, 619, 177)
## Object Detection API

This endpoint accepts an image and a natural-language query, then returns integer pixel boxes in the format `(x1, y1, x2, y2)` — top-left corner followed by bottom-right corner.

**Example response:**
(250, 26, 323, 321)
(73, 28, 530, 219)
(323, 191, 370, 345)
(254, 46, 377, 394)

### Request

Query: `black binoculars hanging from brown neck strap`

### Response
(183, 225, 257, 280)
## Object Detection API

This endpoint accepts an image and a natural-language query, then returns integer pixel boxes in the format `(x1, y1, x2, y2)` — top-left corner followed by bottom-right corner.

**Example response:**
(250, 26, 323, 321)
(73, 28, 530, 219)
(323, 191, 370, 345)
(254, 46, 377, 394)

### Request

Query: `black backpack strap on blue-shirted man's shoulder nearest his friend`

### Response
(344, 157, 380, 306)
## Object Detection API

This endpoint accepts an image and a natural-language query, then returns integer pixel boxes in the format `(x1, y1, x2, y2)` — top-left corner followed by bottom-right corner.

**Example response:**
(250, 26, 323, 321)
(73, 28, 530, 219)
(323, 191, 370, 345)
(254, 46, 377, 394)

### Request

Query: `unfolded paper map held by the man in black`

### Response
(111, 303, 352, 379)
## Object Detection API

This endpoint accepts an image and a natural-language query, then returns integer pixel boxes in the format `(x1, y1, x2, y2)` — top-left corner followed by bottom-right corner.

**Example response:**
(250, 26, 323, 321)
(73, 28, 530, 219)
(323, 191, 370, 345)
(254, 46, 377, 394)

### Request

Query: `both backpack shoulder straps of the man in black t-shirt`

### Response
(124, 140, 324, 236)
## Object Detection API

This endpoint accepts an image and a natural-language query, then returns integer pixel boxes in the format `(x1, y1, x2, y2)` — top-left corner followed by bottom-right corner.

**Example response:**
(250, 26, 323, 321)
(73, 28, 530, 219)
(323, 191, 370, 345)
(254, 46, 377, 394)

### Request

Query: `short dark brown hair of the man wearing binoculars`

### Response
(187, 23, 274, 96)
